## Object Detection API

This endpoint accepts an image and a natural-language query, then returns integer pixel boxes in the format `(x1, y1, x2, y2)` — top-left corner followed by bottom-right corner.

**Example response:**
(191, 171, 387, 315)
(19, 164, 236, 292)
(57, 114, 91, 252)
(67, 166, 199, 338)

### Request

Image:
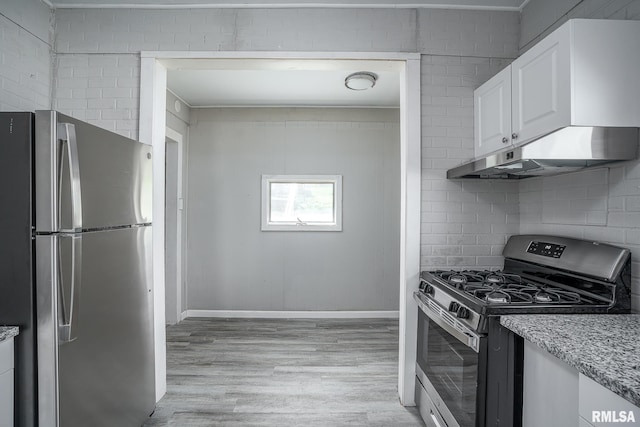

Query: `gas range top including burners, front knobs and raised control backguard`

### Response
(414, 235, 631, 332)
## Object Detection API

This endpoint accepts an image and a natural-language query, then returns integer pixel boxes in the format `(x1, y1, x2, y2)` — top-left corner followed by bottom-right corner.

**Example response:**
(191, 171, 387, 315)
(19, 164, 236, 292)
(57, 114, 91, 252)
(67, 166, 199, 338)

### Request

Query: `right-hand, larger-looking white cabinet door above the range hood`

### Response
(511, 21, 571, 144)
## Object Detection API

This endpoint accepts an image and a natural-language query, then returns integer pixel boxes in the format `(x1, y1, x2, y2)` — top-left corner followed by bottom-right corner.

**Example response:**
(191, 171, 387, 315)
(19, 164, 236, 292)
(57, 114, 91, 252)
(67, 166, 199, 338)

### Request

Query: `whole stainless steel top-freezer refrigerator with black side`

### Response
(0, 111, 155, 427)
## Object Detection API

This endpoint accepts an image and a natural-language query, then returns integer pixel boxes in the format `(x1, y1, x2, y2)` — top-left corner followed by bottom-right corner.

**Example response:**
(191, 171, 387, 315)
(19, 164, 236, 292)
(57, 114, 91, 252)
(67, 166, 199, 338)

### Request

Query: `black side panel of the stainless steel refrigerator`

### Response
(0, 112, 36, 427)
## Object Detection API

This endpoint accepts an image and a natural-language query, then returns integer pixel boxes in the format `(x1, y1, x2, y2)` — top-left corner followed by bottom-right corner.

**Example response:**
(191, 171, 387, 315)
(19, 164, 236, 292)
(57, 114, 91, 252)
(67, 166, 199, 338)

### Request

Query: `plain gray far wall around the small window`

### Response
(187, 108, 400, 310)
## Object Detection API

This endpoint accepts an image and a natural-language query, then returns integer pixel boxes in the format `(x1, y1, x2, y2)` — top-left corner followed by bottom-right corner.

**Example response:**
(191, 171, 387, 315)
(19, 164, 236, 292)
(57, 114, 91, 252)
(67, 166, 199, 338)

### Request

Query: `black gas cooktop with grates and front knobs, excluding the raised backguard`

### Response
(415, 269, 631, 333)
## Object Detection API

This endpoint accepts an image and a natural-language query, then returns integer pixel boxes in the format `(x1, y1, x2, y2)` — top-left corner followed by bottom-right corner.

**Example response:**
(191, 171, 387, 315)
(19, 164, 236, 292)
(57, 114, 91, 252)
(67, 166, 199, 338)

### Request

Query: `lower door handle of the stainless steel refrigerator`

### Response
(58, 234, 82, 343)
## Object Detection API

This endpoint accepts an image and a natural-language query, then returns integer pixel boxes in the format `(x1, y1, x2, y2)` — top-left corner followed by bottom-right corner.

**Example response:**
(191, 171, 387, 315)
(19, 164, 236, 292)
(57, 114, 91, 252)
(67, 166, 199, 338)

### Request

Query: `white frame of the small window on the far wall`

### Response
(261, 175, 342, 231)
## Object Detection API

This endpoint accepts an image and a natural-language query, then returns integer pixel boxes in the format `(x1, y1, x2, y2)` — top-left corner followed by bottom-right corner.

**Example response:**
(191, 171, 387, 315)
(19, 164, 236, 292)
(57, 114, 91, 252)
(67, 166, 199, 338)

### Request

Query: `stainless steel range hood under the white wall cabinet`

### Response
(447, 126, 639, 179)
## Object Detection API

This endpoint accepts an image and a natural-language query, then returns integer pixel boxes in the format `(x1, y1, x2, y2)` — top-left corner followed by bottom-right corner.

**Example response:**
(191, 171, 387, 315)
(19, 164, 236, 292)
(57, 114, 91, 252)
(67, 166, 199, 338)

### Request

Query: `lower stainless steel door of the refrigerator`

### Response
(36, 226, 155, 427)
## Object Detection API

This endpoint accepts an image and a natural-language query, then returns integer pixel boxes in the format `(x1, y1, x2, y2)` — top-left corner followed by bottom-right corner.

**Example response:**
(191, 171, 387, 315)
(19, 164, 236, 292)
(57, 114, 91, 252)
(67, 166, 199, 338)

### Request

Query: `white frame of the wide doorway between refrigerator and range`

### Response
(139, 51, 421, 406)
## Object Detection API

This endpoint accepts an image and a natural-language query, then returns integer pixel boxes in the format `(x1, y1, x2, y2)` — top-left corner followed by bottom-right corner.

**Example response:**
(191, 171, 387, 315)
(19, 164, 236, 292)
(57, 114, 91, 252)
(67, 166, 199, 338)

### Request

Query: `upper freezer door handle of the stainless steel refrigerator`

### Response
(58, 123, 82, 232)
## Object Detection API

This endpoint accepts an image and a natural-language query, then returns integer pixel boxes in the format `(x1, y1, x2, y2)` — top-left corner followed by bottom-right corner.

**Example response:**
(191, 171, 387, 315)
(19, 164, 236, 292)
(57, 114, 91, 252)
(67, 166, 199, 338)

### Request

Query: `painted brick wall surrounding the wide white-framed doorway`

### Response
(48, 9, 519, 284)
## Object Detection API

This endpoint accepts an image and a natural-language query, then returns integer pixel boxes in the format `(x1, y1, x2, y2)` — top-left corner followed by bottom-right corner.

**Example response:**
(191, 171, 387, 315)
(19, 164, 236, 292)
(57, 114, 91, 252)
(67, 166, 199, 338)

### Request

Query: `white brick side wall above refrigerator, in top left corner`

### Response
(0, 0, 51, 111)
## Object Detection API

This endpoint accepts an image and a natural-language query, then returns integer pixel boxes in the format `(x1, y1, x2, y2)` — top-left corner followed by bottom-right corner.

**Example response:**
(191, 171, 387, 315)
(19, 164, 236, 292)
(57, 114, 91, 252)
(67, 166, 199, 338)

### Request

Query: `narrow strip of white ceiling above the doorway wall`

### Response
(43, 0, 529, 10)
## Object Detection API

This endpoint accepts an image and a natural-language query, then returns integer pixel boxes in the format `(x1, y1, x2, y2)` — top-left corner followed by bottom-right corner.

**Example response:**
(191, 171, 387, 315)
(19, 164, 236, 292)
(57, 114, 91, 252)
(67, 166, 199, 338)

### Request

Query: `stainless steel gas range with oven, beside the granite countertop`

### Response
(414, 235, 631, 427)
